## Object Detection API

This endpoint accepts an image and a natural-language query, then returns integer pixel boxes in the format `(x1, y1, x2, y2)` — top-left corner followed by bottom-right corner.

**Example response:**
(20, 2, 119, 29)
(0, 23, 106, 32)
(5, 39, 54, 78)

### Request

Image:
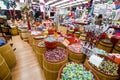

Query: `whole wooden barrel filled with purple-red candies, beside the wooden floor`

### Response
(43, 48, 68, 80)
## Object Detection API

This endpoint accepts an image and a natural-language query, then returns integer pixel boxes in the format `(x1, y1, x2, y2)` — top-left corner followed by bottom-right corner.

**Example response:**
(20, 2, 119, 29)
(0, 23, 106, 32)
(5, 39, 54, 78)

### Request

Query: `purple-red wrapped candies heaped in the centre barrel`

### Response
(45, 47, 67, 62)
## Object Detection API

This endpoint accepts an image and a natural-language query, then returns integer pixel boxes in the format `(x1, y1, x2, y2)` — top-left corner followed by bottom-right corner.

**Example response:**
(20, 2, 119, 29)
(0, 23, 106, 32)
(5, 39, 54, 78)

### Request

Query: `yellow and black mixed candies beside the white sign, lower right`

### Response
(98, 60, 118, 75)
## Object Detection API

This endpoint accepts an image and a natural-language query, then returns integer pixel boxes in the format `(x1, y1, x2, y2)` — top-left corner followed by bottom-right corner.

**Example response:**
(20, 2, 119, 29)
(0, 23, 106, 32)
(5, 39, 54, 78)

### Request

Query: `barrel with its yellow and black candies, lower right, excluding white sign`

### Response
(84, 54, 120, 80)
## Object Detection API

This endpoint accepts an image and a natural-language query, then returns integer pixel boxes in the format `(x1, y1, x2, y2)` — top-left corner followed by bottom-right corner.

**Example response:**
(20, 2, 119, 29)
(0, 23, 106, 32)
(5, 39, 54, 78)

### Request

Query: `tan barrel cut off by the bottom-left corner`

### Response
(0, 55, 12, 80)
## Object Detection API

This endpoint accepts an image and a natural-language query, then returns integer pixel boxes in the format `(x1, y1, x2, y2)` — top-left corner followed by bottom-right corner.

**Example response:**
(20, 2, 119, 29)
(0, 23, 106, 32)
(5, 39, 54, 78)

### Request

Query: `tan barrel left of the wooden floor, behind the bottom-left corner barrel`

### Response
(0, 43, 16, 69)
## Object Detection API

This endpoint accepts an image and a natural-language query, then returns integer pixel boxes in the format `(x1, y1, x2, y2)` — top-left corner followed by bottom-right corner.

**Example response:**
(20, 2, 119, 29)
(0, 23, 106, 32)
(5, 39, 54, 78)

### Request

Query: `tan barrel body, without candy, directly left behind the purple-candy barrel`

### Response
(35, 46, 46, 69)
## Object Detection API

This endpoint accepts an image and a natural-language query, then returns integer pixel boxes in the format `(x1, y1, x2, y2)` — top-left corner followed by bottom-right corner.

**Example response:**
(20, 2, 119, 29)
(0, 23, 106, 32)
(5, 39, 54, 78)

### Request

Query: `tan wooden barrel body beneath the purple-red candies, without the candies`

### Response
(43, 49, 68, 80)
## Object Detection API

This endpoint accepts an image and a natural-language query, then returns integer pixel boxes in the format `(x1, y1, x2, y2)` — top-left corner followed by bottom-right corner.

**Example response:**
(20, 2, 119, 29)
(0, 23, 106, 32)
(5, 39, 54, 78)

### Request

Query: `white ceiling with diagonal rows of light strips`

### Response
(15, 0, 108, 8)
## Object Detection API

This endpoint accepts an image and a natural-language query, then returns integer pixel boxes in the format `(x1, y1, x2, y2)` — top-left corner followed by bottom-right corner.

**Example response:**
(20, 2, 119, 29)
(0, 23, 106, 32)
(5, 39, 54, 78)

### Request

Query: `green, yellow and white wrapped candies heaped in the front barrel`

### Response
(60, 63, 95, 80)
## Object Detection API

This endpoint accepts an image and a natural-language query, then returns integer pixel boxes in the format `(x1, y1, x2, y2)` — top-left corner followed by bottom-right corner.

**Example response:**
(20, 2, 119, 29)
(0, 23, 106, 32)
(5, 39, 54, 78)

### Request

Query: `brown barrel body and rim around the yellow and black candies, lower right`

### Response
(84, 55, 120, 80)
